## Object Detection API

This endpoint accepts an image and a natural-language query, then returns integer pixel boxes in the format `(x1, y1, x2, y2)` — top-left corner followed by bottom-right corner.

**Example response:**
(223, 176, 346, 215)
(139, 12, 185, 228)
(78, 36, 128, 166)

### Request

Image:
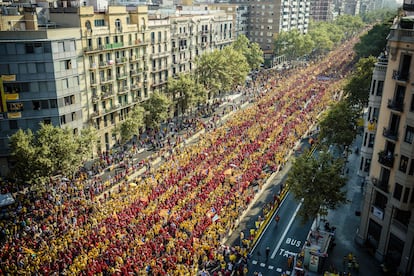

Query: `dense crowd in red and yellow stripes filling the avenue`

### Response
(0, 35, 355, 275)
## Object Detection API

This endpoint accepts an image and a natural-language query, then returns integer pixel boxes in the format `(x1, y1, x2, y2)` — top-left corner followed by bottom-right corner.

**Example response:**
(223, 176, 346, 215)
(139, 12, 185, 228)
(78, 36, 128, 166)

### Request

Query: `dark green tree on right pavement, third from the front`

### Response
(344, 56, 376, 107)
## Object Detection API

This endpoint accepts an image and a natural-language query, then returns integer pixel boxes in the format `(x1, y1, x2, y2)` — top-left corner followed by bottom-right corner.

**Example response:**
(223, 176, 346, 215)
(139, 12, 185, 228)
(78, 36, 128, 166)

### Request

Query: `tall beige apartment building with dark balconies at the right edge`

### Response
(357, 0, 414, 275)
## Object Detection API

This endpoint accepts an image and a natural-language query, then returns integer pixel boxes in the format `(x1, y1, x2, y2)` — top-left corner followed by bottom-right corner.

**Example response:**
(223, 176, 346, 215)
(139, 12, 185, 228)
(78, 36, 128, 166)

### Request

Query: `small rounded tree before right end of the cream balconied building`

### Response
(144, 92, 171, 129)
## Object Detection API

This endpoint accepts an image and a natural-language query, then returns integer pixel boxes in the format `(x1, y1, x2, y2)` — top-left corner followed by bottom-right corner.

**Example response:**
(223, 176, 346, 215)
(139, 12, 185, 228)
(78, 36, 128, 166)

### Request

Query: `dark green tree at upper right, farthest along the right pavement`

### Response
(354, 23, 390, 58)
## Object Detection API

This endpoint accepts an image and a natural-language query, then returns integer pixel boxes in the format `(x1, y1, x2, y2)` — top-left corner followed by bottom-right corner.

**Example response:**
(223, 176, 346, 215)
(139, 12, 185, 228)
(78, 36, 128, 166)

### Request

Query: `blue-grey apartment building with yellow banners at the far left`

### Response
(0, 7, 85, 175)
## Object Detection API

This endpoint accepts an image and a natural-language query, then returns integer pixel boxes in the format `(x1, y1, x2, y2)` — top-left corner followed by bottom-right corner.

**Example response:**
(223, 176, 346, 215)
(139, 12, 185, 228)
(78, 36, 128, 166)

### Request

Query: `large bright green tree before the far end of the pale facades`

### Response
(195, 50, 230, 98)
